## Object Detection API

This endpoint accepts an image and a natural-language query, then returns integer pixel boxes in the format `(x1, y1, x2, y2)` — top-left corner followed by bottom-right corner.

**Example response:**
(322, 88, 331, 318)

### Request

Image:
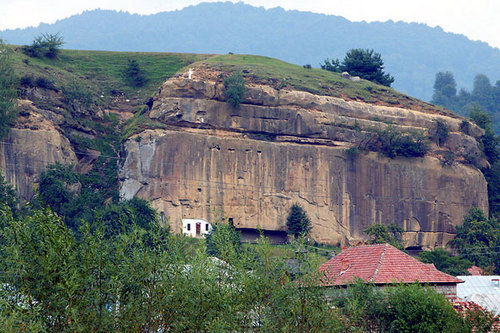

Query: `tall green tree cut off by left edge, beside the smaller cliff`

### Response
(0, 39, 17, 139)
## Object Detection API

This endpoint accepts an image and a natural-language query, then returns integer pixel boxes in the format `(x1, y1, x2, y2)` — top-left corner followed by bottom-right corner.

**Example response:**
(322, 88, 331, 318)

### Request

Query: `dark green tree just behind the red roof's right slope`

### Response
(419, 248, 473, 276)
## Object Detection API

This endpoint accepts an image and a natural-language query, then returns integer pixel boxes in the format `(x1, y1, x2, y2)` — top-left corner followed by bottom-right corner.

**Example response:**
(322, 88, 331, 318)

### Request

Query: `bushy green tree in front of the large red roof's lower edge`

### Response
(332, 280, 467, 333)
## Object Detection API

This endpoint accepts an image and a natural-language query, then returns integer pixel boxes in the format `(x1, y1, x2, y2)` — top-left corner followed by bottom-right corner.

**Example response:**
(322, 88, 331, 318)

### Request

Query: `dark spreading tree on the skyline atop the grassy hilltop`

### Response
(321, 49, 394, 87)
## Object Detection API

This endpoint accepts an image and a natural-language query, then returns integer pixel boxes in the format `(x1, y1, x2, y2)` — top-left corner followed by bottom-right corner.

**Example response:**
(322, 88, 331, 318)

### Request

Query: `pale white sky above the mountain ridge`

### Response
(0, 0, 500, 48)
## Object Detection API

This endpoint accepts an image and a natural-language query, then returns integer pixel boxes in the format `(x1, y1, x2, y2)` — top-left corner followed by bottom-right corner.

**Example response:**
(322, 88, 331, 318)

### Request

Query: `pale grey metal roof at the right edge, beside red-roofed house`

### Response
(457, 275, 500, 315)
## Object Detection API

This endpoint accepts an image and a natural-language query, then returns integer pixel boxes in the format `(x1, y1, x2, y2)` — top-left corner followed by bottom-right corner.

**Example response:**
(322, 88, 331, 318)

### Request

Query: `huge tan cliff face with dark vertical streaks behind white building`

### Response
(120, 70, 488, 247)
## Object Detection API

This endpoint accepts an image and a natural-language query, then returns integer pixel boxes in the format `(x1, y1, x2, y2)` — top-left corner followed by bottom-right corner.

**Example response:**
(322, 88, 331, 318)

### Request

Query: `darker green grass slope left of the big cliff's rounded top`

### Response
(12, 47, 210, 99)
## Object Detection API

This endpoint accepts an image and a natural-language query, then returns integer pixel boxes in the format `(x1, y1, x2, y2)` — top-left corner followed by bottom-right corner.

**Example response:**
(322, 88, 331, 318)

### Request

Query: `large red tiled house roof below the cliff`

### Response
(319, 244, 463, 286)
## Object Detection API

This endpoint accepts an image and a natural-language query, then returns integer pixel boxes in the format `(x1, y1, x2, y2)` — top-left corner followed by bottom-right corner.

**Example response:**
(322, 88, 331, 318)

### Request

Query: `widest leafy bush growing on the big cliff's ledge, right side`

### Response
(378, 126, 429, 158)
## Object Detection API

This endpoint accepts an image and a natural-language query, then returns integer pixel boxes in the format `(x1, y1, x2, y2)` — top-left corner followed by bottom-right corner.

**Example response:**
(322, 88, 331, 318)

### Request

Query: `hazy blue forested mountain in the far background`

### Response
(0, 2, 500, 100)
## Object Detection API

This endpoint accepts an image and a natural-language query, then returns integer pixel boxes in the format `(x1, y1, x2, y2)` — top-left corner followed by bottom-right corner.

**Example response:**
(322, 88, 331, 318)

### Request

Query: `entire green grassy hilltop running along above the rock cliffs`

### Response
(13, 47, 446, 119)
